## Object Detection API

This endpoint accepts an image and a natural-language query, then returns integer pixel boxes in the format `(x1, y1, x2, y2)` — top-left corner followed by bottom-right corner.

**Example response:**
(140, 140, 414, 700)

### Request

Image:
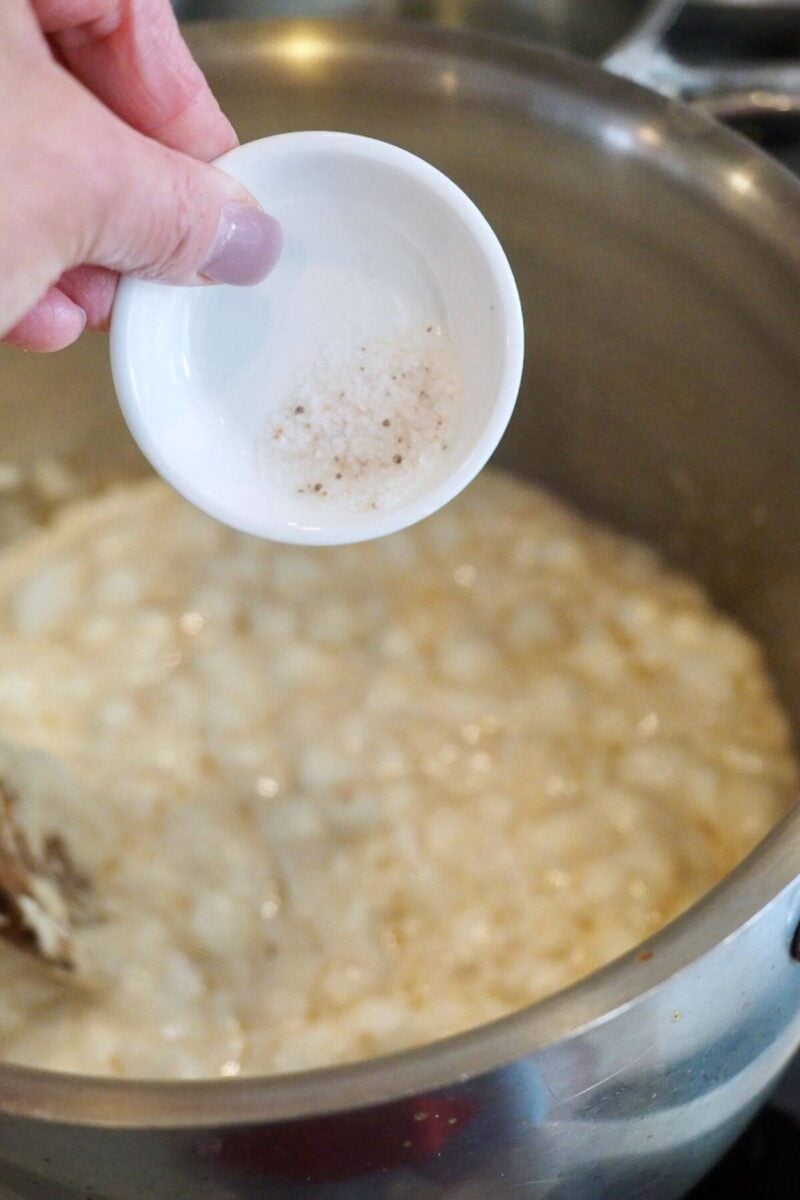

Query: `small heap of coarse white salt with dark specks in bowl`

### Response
(259, 325, 461, 510)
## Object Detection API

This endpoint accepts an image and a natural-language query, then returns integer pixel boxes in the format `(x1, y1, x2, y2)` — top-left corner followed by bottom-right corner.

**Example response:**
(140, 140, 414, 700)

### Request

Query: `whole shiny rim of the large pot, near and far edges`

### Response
(0, 14, 800, 1129)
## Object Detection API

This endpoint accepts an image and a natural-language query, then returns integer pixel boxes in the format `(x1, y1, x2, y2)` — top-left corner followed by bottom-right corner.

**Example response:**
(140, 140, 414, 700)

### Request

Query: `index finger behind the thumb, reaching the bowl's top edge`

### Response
(32, 0, 236, 161)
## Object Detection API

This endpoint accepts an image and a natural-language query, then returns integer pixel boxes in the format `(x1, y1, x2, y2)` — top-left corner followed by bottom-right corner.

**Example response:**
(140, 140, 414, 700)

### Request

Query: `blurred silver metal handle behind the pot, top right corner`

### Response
(603, 0, 800, 121)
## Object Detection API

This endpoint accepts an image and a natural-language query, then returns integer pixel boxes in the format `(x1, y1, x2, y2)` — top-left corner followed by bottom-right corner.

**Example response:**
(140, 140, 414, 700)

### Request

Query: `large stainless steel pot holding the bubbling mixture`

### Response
(0, 23, 800, 1200)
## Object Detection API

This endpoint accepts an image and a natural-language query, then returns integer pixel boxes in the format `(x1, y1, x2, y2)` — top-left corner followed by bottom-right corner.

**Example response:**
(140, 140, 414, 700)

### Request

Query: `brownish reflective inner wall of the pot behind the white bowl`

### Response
(0, 23, 800, 727)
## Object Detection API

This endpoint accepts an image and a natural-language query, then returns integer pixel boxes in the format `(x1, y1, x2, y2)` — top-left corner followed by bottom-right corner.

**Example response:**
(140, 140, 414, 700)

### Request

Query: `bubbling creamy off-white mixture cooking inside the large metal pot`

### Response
(0, 473, 796, 1076)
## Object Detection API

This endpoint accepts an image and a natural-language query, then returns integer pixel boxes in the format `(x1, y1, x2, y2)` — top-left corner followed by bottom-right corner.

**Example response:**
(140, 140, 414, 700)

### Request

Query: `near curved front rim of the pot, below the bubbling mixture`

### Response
(0, 804, 800, 1129)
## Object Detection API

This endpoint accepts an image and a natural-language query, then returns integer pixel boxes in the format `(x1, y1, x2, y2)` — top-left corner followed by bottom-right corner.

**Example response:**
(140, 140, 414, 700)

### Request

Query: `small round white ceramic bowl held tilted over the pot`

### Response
(110, 132, 524, 545)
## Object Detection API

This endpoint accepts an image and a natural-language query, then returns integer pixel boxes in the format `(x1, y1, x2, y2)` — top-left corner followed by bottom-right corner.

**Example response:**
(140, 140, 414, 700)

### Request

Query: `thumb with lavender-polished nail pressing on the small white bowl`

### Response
(0, 67, 281, 332)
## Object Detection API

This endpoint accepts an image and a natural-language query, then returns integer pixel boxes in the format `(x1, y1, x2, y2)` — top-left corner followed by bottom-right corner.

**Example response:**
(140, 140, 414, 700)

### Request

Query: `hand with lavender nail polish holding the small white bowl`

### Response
(0, 0, 281, 350)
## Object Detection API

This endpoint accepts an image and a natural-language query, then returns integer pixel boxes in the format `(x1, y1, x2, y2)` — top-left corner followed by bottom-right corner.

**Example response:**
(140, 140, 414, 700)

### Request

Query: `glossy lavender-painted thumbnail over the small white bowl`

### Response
(200, 203, 283, 286)
